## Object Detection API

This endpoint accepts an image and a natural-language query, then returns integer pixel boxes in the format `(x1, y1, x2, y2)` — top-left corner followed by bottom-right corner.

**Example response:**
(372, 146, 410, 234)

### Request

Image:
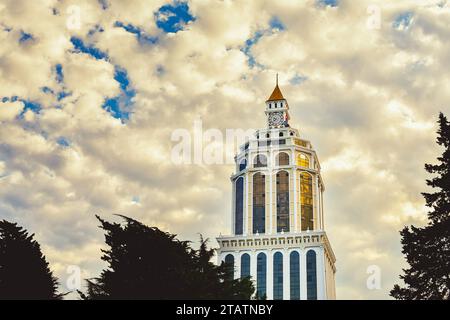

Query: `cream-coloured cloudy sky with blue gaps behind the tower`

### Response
(0, 0, 450, 299)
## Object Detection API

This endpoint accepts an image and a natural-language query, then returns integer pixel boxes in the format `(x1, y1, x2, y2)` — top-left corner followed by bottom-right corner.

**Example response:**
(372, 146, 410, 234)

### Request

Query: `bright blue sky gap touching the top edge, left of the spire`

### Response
(155, 0, 195, 33)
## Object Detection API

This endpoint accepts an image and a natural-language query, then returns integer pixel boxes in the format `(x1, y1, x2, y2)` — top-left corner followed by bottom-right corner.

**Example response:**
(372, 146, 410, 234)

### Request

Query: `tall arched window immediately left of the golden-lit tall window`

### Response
(277, 171, 289, 232)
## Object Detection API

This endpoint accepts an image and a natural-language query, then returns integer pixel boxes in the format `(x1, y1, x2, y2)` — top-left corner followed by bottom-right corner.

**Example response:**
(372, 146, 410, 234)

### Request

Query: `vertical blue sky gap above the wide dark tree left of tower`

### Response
(103, 66, 136, 123)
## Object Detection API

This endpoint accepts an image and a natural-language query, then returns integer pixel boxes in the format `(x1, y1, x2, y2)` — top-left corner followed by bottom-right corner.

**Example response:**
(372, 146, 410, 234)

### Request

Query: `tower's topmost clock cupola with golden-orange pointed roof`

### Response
(266, 74, 289, 129)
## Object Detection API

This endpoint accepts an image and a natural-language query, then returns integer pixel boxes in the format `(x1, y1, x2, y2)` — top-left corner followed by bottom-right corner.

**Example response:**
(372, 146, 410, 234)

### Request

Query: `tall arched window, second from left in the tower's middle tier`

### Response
(253, 172, 266, 233)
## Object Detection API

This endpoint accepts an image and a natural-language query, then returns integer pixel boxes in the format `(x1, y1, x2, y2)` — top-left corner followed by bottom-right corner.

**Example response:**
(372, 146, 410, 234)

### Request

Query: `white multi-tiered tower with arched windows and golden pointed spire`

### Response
(217, 75, 336, 300)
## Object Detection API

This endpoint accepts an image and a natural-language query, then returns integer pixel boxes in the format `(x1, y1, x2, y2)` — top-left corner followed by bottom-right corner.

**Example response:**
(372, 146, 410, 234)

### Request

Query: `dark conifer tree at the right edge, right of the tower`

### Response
(391, 113, 450, 300)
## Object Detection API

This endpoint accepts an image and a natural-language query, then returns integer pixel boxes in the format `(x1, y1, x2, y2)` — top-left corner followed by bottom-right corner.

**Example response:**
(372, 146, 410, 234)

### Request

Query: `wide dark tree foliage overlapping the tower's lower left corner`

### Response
(80, 216, 254, 299)
